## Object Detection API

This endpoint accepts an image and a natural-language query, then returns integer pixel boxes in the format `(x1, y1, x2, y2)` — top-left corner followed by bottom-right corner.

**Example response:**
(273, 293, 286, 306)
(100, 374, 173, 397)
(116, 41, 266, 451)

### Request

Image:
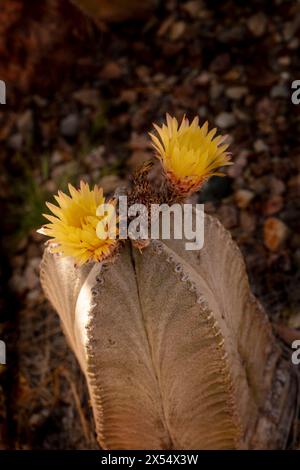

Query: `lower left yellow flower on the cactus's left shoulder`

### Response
(40, 181, 117, 265)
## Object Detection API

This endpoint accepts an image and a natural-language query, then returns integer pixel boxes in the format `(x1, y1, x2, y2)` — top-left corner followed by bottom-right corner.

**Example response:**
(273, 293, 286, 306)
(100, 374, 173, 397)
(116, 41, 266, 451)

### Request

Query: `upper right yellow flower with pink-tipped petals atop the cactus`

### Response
(150, 114, 231, 195)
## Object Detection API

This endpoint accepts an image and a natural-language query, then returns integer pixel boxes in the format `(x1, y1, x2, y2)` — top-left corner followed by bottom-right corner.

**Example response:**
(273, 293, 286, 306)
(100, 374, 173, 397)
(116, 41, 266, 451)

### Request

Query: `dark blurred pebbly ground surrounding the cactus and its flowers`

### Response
(0, 0, 300, 449)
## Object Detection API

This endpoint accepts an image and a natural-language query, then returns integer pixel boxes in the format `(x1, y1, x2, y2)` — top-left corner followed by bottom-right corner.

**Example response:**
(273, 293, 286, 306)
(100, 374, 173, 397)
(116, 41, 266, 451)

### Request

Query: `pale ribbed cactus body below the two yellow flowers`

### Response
(41, 216, 299, 449)
